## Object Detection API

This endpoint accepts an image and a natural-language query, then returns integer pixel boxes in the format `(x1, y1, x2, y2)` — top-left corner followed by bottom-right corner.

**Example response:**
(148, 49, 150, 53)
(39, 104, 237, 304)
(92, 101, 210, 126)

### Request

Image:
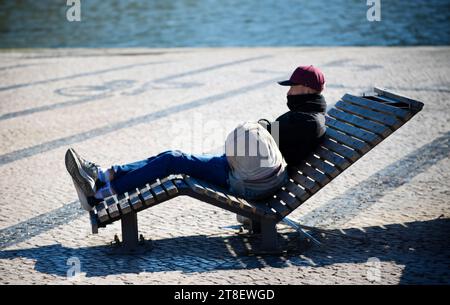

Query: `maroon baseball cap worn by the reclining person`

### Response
(278, 66, 325, 91)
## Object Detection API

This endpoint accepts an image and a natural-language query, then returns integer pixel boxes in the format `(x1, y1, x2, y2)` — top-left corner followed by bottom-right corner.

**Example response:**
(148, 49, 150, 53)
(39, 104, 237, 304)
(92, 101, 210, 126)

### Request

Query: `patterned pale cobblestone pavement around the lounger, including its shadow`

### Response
(0, 47, 450, 284)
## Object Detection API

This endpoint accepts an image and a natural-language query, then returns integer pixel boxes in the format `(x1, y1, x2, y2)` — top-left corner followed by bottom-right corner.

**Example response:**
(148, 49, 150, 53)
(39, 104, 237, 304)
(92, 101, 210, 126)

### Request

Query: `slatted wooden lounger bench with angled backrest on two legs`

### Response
(86, 88, 423, 251)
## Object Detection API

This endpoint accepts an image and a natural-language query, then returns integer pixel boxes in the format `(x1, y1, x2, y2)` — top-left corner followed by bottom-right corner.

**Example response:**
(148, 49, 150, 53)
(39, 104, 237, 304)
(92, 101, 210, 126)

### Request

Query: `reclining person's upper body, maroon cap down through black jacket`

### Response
(260, 66, 327, 165)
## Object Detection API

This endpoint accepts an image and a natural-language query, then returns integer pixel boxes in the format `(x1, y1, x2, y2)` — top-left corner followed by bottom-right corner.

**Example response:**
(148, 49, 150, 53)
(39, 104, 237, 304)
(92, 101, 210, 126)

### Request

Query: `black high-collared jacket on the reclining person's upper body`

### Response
(260, 94, 326, 165)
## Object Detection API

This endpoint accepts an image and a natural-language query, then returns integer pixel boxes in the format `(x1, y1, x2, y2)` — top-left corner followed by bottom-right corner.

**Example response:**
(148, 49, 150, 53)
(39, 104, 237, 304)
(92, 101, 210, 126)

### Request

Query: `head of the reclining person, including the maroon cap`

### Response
(278, 66, 325, 95)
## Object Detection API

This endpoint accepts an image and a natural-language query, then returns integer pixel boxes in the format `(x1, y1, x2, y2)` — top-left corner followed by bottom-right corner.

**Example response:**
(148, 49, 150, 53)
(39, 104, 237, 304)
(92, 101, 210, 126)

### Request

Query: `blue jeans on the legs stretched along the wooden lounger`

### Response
(111, 150, 230, 194)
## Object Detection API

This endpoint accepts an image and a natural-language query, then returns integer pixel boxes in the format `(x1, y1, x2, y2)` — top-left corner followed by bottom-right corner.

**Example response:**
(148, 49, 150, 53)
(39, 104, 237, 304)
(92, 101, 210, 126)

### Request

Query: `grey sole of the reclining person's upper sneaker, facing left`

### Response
(65, 148, 95, 196)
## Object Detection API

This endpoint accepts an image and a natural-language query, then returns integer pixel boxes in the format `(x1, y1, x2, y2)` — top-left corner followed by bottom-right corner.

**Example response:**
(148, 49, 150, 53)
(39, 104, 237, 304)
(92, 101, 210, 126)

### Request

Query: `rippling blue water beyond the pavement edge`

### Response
(0, 0, 450, 48)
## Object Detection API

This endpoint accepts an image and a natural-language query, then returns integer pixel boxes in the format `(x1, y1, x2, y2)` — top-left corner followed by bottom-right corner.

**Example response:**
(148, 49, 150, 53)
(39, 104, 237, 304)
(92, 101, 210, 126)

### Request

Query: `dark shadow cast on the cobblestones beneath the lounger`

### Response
(0, 218, 450, 284)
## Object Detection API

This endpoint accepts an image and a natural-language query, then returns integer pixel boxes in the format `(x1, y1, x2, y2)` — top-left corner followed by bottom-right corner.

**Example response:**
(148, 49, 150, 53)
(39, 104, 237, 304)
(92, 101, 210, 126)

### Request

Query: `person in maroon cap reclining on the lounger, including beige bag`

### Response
(65, 66, 326, 211)
